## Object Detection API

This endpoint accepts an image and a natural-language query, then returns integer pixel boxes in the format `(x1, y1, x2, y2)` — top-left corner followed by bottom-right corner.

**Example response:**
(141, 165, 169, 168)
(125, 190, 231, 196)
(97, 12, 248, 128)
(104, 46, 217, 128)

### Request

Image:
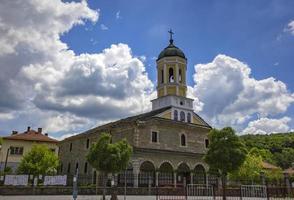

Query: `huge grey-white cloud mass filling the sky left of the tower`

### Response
(0, 0, 153, 137)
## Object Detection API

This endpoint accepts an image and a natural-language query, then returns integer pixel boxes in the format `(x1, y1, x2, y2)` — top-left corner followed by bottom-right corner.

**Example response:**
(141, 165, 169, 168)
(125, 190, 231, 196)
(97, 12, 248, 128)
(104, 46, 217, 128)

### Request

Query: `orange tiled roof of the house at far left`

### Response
(3, 130, 58, 143)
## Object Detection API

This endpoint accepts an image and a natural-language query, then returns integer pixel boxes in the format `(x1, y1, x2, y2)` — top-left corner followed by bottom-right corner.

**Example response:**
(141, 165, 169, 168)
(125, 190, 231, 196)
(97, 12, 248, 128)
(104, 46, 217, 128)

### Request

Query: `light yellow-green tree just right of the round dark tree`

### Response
(229, 151, 263, 181)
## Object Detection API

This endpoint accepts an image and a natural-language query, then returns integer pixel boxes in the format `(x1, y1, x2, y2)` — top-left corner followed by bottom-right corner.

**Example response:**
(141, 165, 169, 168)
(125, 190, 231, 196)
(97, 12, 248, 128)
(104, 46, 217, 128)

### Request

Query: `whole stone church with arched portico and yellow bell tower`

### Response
(59, 31, 211, 187)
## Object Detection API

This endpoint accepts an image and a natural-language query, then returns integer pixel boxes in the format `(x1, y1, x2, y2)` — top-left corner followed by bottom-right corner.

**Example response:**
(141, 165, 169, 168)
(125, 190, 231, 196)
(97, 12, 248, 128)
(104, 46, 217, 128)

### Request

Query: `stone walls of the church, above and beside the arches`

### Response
(59, 118, 209, 178)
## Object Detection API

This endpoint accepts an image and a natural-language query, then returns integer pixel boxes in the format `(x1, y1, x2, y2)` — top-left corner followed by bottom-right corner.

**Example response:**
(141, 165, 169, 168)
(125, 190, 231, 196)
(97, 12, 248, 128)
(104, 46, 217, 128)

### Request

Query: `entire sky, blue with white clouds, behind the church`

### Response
(0, 0, 294, 139)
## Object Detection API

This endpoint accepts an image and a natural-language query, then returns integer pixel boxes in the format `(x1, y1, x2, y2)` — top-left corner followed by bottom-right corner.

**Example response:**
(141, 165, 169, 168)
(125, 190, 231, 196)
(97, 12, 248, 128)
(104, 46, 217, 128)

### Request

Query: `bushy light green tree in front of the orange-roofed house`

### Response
(17, 144, 59, 176)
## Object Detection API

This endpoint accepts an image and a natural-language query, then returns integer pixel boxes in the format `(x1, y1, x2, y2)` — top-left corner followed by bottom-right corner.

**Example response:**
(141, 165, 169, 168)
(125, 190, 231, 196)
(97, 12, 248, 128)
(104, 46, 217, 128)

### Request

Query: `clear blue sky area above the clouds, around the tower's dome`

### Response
(62, 0, 294, 86)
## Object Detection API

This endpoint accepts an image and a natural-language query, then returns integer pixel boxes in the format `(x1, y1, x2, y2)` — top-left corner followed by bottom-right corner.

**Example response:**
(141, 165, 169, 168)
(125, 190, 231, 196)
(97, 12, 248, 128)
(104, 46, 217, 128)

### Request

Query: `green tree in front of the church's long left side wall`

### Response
(87, 133, 133, 200)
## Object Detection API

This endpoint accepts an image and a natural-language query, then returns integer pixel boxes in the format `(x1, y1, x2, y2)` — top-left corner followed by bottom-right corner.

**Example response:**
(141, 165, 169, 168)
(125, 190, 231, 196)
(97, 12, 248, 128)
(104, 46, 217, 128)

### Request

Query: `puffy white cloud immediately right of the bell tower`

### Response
(192, 55, 294, 127)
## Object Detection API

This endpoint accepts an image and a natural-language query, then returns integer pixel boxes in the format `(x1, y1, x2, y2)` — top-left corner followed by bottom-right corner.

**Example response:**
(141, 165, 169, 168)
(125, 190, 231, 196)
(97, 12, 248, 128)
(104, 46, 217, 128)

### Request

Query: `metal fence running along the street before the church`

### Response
(0, 171, 294, 200)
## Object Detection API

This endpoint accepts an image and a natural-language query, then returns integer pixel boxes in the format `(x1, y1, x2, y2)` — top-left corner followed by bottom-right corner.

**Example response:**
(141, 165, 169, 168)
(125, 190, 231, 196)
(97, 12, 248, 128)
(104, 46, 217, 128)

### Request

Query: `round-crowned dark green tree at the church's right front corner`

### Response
(204, 127, 247, 200)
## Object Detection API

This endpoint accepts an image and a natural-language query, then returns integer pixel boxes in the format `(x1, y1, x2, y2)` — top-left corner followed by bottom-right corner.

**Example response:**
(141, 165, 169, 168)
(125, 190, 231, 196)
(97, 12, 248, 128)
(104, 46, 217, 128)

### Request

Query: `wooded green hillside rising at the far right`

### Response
(240, 132, 294, 169)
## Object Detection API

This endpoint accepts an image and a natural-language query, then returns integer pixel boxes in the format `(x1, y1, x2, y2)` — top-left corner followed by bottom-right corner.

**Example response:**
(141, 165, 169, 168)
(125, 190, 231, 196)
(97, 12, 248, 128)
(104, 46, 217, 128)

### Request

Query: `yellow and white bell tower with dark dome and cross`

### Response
(152, 30, 193, 118)
